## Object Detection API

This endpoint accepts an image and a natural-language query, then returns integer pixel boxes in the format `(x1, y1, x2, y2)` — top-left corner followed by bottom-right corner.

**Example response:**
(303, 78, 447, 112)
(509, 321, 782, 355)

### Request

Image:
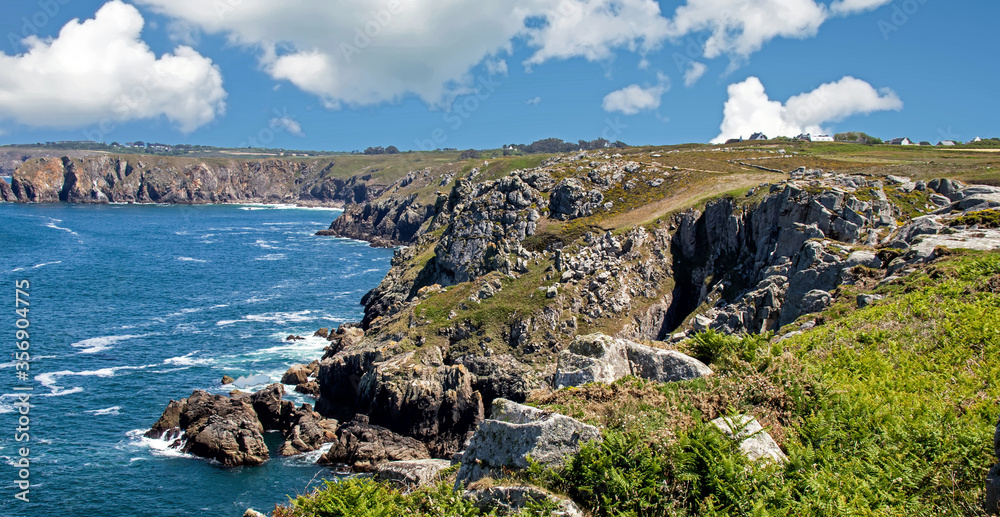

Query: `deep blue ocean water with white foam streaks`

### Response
(0, 203, 392, 517)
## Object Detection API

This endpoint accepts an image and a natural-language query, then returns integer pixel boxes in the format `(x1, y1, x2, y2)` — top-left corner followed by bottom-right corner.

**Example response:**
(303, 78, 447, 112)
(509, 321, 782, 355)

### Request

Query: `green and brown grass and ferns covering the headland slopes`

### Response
(276, 143, 1000, 516)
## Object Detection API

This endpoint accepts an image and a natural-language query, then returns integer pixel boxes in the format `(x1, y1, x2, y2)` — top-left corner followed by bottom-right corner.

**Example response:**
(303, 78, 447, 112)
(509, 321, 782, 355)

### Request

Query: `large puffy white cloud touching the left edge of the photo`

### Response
(0, 0, 226, 132)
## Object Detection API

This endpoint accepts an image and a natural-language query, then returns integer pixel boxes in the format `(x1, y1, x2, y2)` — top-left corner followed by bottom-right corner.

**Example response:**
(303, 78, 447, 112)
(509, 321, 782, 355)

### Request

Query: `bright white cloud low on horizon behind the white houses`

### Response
(712, 76, 903, 143)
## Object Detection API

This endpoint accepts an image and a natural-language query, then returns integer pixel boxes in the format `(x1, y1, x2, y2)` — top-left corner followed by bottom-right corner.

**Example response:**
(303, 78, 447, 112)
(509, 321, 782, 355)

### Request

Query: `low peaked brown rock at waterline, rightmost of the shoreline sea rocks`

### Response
(318, 415, 431, 472)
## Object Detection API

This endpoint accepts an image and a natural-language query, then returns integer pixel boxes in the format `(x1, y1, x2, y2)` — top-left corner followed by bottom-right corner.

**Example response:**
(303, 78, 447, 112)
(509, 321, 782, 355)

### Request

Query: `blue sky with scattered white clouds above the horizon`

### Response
(0, 0, 1000, 151)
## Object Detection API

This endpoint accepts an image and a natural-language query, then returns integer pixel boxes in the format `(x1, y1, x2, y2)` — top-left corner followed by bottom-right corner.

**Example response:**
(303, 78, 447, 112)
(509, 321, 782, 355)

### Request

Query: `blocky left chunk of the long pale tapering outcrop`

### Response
(553, 334, 632, 388)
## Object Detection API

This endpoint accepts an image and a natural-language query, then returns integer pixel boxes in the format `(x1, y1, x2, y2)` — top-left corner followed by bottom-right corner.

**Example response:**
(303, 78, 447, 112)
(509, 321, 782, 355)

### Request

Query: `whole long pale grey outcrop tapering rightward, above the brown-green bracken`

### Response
(553, 334, 712, 388)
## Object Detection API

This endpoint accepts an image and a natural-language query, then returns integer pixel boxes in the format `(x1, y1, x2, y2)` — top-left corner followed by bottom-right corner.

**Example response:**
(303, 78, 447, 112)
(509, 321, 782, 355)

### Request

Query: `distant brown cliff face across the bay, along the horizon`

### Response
(0, 156, 384, 204)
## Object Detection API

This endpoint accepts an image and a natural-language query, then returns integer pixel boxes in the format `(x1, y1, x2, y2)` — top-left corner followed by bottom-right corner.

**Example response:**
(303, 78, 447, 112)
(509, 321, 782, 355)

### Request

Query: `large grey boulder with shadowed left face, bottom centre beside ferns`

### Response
(455, 399, 601, 490)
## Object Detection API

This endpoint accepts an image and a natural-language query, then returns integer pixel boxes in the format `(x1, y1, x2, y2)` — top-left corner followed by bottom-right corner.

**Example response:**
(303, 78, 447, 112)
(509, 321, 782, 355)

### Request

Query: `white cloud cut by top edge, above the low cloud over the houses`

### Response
(670, 0, 828, 58)
